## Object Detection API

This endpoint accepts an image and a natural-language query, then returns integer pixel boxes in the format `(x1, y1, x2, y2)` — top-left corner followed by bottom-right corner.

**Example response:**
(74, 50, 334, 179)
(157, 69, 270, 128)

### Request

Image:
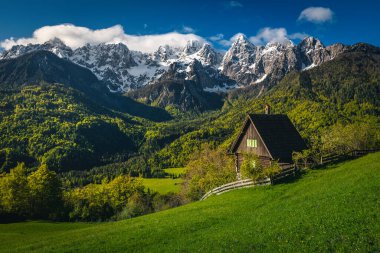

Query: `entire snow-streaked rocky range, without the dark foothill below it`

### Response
(0, 35, 346, 92)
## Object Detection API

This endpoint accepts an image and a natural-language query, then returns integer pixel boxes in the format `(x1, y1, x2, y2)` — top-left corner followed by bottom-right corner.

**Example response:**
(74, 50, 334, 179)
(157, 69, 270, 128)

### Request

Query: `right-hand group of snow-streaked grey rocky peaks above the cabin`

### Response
(220, 35, 345, 86)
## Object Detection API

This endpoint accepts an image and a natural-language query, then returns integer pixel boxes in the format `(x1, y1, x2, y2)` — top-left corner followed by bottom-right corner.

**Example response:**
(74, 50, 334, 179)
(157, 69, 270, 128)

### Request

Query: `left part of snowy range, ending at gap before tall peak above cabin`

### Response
(0, 39, 227, 92)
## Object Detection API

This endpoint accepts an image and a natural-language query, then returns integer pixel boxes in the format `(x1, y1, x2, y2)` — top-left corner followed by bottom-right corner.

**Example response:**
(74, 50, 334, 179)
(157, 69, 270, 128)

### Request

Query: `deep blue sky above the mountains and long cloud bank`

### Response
(0, 0, 380, 51)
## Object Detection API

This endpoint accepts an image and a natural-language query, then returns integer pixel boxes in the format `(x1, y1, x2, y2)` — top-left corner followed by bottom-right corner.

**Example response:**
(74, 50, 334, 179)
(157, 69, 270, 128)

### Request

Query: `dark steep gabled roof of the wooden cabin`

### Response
(230, 114, 307, 162)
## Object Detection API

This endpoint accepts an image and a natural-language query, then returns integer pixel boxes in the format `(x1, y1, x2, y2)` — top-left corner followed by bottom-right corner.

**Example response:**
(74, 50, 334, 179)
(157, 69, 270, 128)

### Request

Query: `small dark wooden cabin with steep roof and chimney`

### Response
(229, 105, 307, 179)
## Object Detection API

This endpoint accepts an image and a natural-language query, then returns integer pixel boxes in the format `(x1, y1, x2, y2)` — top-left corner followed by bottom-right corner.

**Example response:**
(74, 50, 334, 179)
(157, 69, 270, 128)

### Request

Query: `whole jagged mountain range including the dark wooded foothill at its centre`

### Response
(0, 38, 378, 113)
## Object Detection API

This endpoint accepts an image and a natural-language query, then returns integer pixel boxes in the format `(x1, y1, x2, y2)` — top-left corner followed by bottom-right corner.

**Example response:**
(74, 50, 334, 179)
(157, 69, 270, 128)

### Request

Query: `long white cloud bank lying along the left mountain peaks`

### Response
(0, 24, 206, 52)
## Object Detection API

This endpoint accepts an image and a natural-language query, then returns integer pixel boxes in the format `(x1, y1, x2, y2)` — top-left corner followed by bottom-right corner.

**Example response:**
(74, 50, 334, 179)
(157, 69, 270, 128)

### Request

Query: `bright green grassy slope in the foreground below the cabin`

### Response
(0, 153, 380, 253)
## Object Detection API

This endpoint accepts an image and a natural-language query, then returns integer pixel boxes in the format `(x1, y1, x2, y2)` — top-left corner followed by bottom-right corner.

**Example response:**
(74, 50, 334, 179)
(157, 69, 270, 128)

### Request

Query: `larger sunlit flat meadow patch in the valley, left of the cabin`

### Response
(143, 178, 183, 194)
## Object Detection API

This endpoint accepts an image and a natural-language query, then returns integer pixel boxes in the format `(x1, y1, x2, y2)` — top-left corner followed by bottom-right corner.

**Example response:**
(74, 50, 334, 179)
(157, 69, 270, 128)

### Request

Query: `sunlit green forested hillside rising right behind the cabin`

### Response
(151, 43, 380, 168)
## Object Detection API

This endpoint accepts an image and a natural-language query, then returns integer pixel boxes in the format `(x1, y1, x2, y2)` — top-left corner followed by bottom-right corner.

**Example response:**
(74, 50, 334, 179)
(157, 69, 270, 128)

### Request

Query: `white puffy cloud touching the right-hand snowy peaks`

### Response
(249, 27, 308, 45)
